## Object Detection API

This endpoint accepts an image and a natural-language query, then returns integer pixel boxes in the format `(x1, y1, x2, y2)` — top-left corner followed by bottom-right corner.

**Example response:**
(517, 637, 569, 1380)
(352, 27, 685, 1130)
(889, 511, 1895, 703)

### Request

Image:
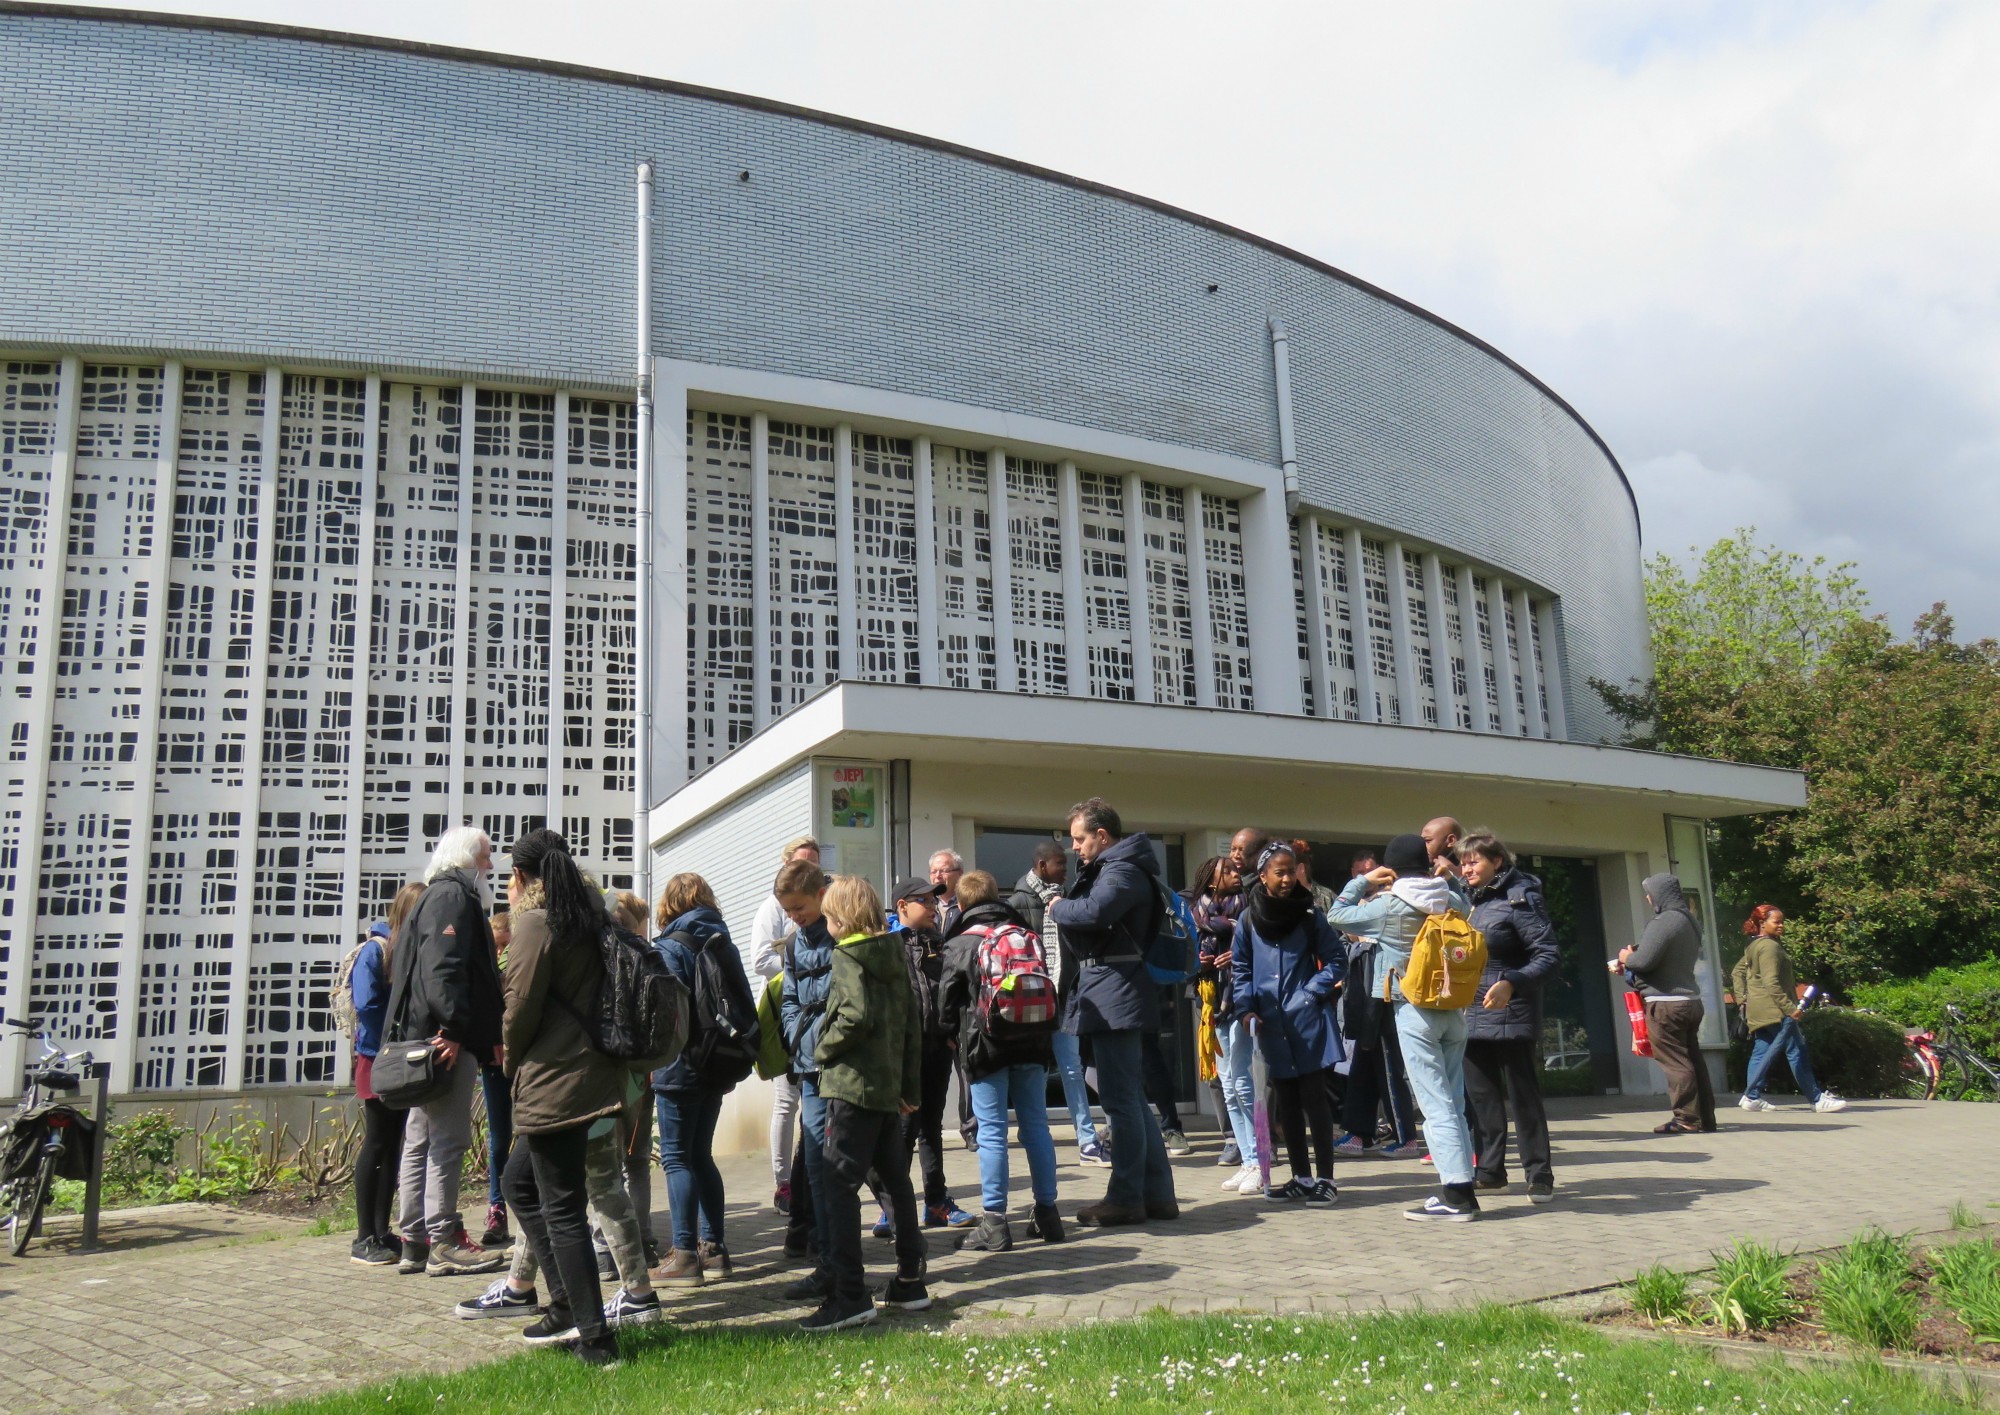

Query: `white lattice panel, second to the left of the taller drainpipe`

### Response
(460, 388, 566, 873)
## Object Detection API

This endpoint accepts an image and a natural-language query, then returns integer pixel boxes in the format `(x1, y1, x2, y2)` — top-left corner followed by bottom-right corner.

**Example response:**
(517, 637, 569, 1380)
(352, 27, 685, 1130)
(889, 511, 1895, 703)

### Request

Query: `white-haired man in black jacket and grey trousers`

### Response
(384, 825, 506, 1277)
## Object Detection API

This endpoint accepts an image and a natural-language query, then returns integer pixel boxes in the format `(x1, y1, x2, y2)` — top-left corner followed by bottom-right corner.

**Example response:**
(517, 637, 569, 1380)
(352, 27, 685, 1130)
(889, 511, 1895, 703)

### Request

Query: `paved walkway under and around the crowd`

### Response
(0, 1101, 2000, 1413)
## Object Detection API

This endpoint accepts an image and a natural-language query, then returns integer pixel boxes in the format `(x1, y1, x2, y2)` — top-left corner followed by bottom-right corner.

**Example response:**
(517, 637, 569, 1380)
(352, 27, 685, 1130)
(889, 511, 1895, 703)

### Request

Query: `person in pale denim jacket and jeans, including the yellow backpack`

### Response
(1326, 835, 1486, 1223)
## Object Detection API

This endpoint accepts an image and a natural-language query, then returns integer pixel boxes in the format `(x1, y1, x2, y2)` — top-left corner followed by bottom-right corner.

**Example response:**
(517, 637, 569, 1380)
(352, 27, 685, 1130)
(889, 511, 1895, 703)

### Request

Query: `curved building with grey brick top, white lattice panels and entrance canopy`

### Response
(0, 4, 1802, 1119)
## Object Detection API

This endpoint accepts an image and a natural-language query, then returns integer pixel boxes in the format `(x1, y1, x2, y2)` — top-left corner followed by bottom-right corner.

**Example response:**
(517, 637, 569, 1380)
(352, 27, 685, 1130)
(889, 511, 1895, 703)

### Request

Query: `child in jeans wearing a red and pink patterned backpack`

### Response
(940, 869, 1066, 1253)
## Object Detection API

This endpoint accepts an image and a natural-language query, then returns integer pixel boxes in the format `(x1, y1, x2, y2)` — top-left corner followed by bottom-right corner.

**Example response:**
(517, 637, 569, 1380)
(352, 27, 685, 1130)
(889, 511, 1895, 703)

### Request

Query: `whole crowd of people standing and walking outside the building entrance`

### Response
(342, 797, 1842, 1365)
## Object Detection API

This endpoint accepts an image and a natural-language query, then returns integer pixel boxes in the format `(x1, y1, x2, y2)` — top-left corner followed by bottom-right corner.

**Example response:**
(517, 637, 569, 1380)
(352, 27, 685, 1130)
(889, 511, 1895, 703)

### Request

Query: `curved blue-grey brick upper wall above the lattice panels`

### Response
(0, 8, 1646, 737)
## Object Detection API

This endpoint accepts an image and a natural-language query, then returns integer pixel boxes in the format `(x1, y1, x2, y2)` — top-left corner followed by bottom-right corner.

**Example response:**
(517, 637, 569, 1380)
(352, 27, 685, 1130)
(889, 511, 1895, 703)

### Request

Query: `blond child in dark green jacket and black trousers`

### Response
(794, 875, 930, 1333)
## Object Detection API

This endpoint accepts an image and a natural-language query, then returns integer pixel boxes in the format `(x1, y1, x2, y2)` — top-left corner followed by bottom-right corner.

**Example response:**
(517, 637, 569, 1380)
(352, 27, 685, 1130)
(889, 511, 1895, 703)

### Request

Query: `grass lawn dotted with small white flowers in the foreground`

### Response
(262, 1307, 1972, 1415)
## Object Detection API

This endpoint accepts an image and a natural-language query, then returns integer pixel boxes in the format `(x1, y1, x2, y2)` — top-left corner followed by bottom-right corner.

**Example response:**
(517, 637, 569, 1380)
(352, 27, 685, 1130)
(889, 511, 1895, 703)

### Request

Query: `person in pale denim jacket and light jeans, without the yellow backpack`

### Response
(1326, 835, 1480, 1223)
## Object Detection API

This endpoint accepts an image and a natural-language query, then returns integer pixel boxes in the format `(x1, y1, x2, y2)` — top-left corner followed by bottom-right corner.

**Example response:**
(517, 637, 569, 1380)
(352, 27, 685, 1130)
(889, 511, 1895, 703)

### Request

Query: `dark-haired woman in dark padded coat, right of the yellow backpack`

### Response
(1458, 829, 1558, 1203)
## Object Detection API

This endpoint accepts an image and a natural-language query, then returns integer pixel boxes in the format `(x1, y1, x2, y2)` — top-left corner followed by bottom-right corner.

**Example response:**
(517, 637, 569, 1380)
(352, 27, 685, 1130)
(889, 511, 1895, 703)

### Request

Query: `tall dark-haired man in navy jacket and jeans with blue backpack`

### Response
(1048, 795, 1180, 1227)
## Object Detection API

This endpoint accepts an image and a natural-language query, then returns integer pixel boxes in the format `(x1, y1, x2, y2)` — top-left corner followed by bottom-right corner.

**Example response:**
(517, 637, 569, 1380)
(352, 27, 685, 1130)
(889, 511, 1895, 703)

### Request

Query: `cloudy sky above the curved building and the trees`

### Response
(74, 0, 2000, 636)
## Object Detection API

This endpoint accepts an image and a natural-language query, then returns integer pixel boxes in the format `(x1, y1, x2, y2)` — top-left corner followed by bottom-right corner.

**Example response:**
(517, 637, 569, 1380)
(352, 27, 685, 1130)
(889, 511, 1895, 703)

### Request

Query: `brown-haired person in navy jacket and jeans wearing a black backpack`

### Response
(652, 873, 760, 1287)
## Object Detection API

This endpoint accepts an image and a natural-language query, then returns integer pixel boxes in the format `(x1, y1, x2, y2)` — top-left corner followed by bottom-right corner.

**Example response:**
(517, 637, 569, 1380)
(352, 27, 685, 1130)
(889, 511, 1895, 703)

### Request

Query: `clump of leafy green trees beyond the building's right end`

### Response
(1596, 530, 2000, 983)
